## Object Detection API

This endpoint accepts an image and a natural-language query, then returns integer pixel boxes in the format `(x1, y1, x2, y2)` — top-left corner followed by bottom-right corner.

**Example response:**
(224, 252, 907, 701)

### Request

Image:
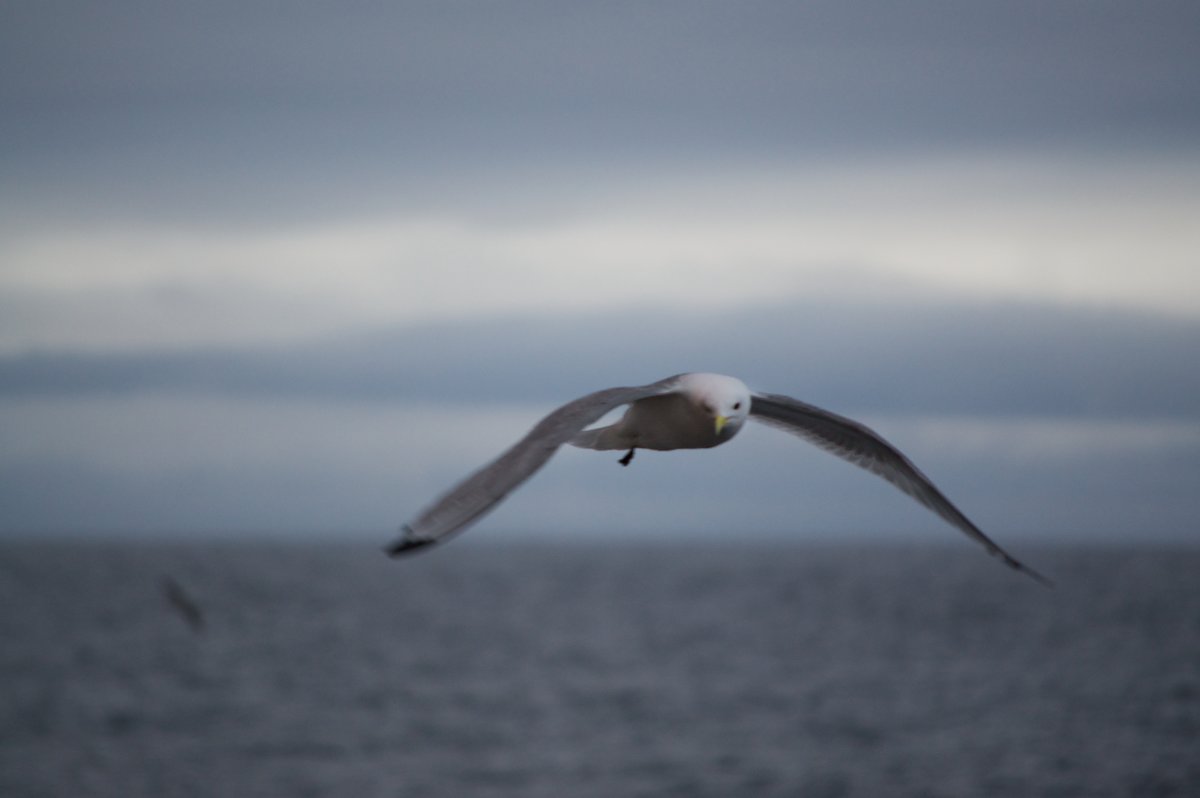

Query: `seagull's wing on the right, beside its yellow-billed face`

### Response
(750, 394, 1050, 584)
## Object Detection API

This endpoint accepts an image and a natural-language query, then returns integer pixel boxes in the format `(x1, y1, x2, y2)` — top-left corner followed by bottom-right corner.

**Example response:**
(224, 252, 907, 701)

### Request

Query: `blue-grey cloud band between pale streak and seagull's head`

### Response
(0, 294, 1200, 416)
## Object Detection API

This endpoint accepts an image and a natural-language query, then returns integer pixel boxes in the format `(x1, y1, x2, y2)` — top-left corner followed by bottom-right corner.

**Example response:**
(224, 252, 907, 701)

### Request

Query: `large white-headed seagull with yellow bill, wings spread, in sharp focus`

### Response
(385, 373, 1050, 584)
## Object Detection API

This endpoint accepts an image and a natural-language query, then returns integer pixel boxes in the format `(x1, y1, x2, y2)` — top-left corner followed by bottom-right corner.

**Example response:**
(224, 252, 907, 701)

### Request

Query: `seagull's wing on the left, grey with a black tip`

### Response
(388, 376, 679, 557)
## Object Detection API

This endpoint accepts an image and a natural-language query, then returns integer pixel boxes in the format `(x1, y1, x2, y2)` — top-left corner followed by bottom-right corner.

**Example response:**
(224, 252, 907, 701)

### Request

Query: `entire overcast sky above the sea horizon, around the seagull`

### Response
(0, 0, 1200, 545)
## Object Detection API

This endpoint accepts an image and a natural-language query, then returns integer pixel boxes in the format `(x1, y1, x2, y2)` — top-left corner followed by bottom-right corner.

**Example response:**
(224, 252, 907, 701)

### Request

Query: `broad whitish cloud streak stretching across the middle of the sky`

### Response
(0, 161, 1200, 352)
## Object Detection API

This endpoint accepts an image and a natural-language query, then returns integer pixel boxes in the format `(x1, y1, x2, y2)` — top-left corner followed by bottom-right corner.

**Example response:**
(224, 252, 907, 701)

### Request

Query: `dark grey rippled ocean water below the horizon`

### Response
(0, 539, 1200, 798)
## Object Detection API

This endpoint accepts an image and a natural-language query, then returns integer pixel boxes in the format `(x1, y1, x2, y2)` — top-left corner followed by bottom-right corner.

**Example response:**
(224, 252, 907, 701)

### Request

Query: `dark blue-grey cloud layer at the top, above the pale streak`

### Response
(0, 1, 1200, 225)
